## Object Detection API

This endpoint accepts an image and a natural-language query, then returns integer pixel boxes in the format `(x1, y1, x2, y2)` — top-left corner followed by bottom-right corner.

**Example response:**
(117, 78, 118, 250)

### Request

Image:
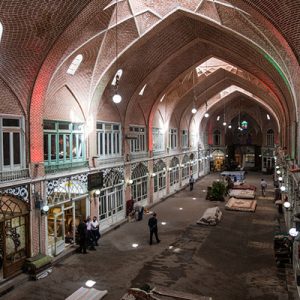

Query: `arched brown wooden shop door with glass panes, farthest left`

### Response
(0, 194, 29, 279)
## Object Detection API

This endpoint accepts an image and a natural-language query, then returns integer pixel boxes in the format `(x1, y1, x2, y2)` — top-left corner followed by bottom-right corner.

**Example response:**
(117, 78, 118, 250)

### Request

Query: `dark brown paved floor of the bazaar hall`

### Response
(2, 173, 296, 300)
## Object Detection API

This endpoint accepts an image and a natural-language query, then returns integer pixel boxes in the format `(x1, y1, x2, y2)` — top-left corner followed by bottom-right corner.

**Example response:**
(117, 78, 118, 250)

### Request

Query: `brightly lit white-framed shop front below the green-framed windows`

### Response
(47, 174, 90, 256)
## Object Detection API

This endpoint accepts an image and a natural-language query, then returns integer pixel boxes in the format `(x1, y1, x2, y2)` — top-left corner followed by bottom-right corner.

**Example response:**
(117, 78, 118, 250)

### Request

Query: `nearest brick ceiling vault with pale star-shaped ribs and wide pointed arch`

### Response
(0, 0, 300, 156)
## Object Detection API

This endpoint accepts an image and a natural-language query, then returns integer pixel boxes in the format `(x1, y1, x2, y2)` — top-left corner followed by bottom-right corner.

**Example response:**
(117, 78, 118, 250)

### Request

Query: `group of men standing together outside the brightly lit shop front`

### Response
(77, 216, 101, 254)
